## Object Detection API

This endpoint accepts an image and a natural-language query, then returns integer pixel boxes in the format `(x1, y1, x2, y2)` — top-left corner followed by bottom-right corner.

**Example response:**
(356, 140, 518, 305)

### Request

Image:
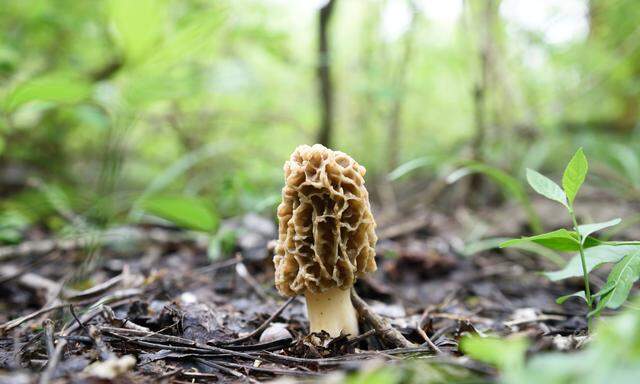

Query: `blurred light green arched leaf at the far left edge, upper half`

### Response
(4, 74, 92, 113)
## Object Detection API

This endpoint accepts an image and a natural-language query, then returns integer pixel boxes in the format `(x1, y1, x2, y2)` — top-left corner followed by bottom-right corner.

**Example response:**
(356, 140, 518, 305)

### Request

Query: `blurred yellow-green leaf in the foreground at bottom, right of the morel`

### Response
(460, 336, 529, 370)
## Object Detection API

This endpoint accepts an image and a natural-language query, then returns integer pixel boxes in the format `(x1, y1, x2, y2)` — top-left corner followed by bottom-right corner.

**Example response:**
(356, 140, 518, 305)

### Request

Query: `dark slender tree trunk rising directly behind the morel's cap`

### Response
(317, 0, 336, 147)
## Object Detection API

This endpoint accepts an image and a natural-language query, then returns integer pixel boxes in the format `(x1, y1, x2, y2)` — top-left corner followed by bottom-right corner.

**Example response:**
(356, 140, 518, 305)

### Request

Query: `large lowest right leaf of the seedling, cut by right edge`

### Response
(589, 250, 640, 316)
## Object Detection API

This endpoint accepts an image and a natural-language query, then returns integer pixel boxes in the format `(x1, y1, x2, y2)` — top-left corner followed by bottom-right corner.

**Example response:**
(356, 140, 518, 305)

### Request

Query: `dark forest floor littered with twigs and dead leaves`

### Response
(0, 188, 636, 383)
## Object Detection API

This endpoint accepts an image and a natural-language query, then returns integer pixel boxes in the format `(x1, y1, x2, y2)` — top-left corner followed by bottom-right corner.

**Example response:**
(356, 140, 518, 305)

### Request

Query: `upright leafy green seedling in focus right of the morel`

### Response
(500, 148, 640, 317)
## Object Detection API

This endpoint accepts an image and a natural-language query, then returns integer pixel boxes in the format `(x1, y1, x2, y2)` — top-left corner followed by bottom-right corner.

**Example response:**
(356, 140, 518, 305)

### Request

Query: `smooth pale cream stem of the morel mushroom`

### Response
(305, 287, 358, 337)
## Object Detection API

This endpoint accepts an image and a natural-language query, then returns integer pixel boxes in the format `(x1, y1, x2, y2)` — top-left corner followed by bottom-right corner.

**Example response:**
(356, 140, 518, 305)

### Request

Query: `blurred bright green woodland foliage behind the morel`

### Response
(0, 0, 640, 242)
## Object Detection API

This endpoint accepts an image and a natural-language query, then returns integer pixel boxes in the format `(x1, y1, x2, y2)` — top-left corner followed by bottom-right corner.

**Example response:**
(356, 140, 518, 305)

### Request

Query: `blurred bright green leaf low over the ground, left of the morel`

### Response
(142, 197, 217, 232)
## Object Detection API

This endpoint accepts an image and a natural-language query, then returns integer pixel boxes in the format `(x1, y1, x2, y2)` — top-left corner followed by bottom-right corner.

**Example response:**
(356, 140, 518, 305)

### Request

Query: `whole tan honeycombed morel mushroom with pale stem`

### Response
(273, 144, 377, 337)
